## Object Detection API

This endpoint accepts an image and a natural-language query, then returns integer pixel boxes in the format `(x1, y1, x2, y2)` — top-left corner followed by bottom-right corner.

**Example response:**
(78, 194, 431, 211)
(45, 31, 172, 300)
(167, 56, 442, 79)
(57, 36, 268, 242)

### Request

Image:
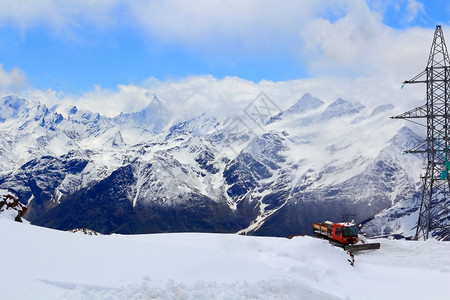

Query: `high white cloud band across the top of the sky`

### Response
(0, 0, 432, 76)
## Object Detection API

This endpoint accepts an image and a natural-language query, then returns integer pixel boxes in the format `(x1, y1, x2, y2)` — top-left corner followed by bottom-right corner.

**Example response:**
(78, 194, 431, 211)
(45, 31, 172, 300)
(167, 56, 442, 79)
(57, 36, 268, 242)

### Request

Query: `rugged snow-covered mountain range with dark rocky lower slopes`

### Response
(0, 94, 440, 236)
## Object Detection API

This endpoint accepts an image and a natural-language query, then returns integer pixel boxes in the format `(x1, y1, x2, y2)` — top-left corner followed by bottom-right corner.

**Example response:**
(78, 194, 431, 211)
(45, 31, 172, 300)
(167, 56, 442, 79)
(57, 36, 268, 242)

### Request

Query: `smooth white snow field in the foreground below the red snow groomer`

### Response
(0, 218, 450, 299)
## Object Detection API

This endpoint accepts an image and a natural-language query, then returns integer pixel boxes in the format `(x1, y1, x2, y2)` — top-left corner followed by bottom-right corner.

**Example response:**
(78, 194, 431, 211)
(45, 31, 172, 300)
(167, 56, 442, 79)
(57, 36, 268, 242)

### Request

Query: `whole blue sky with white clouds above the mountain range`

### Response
(0, 0, 450, 114)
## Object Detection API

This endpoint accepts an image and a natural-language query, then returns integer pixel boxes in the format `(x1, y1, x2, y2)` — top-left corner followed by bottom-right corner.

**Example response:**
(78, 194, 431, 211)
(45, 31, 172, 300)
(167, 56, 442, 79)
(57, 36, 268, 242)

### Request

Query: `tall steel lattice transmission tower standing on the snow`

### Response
(392, 25, 450, 240)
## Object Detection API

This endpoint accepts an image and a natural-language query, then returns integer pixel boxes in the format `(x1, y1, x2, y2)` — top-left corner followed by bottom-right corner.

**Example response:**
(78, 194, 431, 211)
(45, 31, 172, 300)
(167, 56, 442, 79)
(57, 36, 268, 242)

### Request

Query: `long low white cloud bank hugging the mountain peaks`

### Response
(23, 76, 425, 120)
